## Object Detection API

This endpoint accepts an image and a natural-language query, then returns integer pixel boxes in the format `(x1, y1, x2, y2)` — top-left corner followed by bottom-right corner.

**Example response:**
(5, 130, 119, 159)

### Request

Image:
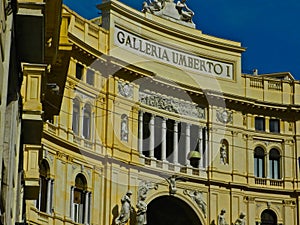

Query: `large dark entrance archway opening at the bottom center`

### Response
(147, 196, 202, 225)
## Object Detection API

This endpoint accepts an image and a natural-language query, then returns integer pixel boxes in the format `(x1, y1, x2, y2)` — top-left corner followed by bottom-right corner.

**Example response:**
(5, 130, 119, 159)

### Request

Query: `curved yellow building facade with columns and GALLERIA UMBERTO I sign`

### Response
(24, 0, 300, 225)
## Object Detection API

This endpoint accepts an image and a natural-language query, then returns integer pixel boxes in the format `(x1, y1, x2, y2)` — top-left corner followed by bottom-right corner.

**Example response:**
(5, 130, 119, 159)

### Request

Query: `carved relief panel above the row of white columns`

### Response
(139, 91, 205, 119)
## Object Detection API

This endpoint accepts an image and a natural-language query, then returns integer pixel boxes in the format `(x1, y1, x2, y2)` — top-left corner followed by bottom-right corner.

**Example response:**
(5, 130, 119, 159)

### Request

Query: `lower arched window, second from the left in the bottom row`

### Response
(71, 174, 91, 224)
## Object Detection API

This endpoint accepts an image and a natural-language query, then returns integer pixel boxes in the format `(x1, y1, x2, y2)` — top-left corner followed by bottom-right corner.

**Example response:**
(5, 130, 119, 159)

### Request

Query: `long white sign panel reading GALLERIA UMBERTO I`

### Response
(114, 27, 233, 79)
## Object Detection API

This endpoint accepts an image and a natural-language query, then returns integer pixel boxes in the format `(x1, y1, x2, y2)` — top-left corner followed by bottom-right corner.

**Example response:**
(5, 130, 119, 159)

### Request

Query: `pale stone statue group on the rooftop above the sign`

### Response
(142, 0, 195, 28)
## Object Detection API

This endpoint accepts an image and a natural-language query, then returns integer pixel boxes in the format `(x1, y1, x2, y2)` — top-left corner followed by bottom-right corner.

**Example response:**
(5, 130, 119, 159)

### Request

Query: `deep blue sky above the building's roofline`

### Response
(64, 0, 300, 80)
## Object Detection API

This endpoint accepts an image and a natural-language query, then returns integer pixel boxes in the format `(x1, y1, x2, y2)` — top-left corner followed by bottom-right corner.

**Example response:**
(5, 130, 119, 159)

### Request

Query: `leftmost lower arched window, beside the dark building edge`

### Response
(36, 159, 54, 214)
